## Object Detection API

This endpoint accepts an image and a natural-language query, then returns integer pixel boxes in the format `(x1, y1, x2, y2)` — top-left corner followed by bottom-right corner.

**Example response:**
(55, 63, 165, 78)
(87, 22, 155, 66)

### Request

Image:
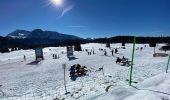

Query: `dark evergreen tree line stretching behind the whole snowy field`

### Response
(0, 36, 170, 53)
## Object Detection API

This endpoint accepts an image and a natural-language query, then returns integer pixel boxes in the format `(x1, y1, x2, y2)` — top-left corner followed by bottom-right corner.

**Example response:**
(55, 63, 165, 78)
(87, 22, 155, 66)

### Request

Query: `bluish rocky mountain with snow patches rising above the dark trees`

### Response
(6, 29, 82, 40)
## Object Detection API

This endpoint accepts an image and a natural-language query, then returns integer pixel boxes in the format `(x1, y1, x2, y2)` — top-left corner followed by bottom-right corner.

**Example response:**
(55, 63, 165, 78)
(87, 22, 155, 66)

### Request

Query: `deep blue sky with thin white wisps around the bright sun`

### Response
(0, 0, 170, 38)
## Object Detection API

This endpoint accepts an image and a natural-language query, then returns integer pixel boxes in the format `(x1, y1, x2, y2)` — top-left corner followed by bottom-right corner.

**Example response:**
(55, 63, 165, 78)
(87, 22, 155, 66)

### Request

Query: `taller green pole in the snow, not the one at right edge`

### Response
(129, 36, 136, 86)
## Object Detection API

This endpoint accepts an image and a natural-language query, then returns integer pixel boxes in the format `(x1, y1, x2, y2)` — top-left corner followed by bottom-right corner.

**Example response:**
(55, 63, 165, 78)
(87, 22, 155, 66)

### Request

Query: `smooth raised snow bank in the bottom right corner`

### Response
(95, 73, 170, 100)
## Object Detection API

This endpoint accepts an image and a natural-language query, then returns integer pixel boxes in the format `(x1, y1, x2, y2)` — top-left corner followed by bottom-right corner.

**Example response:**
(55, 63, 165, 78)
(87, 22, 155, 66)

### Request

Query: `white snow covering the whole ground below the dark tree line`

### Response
(0, 43, 170, 100)
